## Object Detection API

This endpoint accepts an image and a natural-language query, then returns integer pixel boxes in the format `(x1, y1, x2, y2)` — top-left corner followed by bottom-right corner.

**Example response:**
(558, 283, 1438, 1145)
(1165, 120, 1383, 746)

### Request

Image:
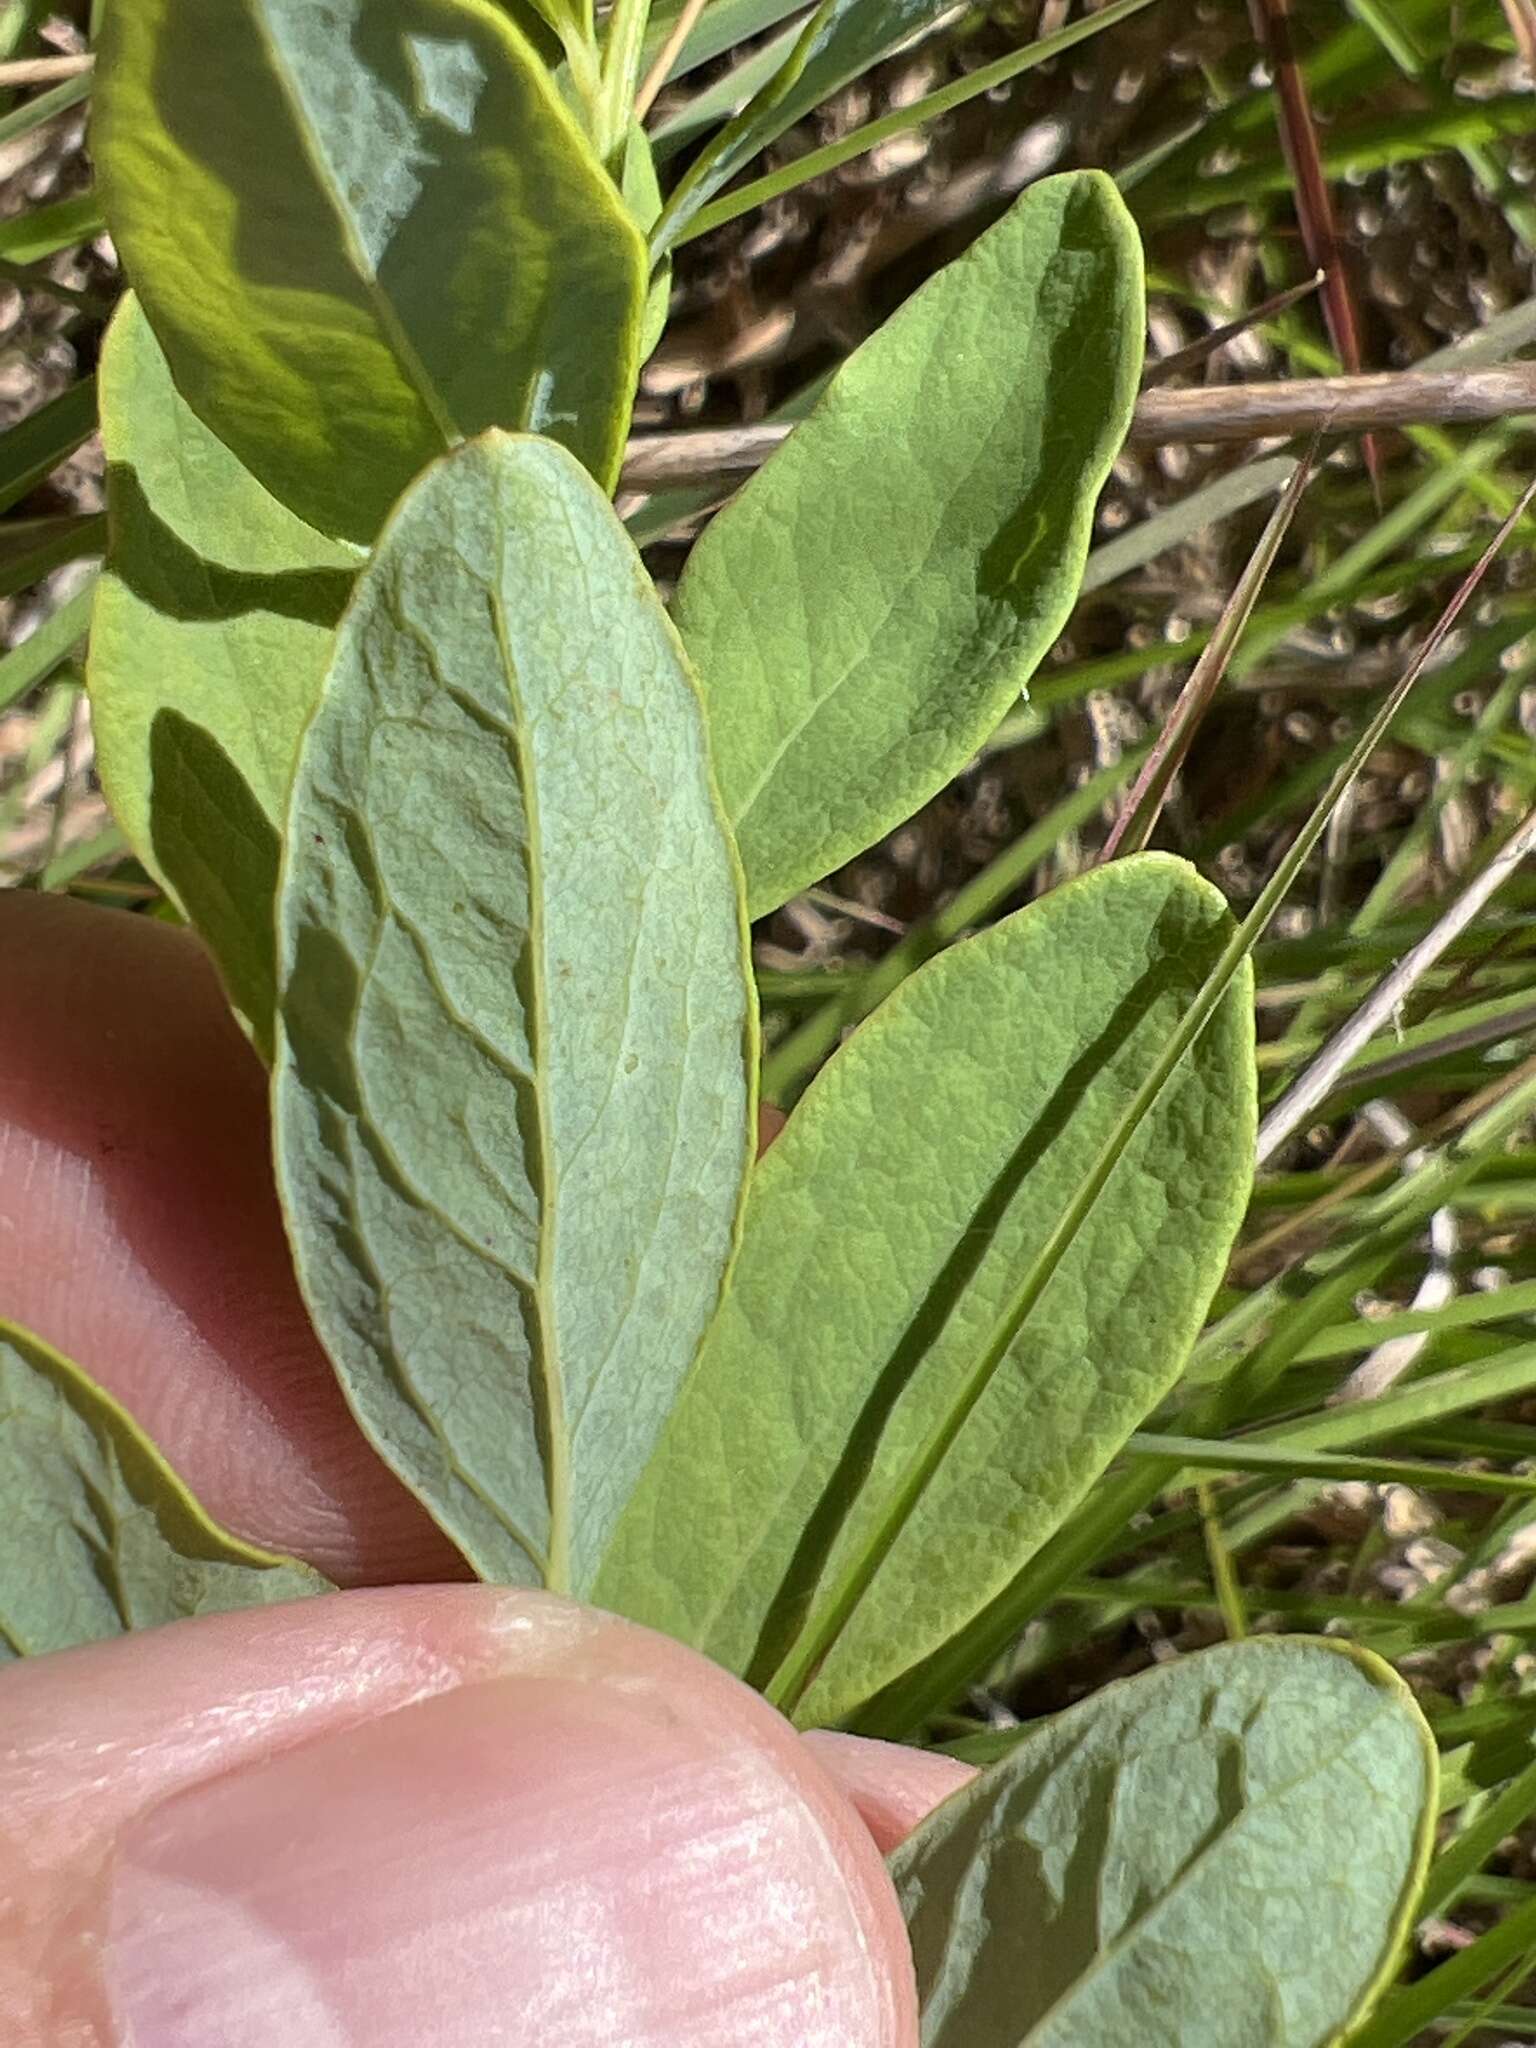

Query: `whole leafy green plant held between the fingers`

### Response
(0, 0, 1436, 2048)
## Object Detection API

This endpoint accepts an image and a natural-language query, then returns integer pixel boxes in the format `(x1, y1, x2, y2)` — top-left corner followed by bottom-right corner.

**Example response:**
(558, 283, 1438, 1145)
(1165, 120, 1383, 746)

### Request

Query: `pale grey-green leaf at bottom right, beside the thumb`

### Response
(889, 1636, 1436, 2048)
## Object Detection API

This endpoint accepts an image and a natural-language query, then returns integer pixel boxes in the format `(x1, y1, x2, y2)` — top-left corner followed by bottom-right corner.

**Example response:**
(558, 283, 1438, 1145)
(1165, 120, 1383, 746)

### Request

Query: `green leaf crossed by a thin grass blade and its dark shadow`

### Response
(596, 854, 1253, 1722)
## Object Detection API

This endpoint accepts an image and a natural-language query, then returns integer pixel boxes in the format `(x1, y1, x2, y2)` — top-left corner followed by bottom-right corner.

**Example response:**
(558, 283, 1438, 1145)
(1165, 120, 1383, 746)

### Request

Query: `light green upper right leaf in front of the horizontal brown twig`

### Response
(676, 172, 1143, 918)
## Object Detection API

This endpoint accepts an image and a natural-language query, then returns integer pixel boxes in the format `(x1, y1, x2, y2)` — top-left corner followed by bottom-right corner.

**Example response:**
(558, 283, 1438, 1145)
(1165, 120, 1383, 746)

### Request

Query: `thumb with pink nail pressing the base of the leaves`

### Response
(0, 1587, 918, 2048)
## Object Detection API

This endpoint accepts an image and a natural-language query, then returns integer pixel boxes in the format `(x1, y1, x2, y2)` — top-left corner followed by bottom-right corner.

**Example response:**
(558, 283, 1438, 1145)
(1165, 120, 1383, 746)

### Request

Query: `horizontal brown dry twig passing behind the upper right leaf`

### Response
(623, 362, 1536, 492)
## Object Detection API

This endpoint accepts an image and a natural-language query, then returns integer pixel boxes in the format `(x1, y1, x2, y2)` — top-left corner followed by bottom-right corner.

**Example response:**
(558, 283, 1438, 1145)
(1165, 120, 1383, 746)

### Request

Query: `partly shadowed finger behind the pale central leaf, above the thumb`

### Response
(0, 891, 465, 1585)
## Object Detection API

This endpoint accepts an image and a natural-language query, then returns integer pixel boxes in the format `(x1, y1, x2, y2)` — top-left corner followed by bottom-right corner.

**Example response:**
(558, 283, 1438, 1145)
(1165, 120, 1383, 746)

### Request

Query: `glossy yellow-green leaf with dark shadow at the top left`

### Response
(94, 0, 645, 543)
